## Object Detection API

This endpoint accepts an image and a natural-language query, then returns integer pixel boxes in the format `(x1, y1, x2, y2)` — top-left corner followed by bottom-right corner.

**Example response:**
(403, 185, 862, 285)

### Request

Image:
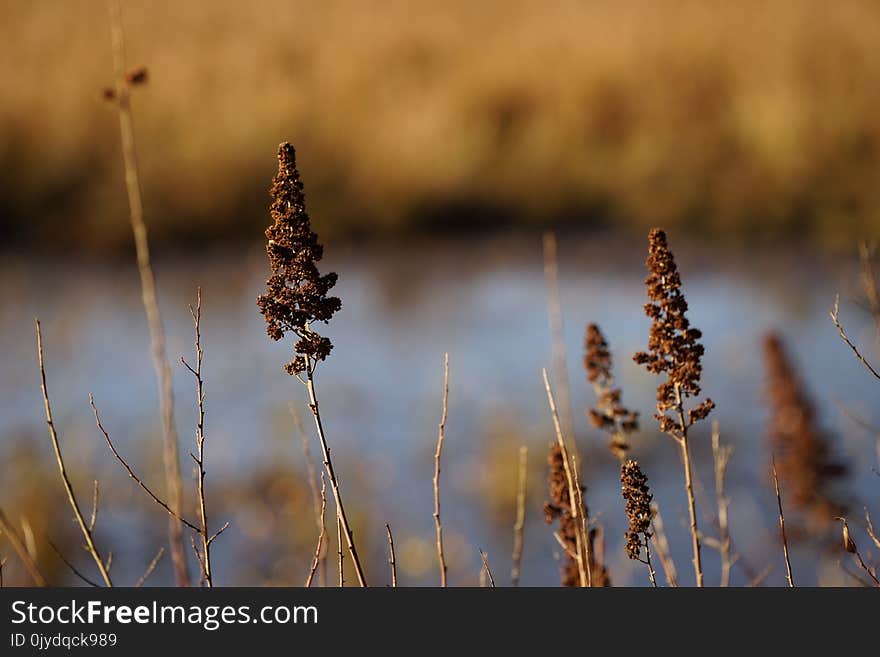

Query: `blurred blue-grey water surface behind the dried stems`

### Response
(0, 235, 880, 585)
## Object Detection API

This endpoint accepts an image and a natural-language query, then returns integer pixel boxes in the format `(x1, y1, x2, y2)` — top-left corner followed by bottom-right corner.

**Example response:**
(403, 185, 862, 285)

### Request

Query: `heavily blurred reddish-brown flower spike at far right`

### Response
(764, 334, 846, 526)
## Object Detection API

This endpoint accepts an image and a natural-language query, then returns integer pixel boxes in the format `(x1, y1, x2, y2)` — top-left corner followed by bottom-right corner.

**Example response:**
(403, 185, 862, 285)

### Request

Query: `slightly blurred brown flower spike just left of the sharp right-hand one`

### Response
(584, 324, 639, 461)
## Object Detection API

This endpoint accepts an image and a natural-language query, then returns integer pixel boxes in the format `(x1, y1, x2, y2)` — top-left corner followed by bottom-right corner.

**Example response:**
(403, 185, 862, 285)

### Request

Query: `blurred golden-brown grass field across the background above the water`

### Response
(0, 0, 880, 249)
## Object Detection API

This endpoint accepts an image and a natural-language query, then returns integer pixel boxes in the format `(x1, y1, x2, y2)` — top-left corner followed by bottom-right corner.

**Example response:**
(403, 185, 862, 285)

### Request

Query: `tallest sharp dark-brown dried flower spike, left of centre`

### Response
(257, 142, 342, 375)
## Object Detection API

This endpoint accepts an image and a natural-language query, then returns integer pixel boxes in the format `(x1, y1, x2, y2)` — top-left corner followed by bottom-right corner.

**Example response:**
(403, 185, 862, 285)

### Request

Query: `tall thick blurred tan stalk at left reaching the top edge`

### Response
(109, 0, 190, 586)
